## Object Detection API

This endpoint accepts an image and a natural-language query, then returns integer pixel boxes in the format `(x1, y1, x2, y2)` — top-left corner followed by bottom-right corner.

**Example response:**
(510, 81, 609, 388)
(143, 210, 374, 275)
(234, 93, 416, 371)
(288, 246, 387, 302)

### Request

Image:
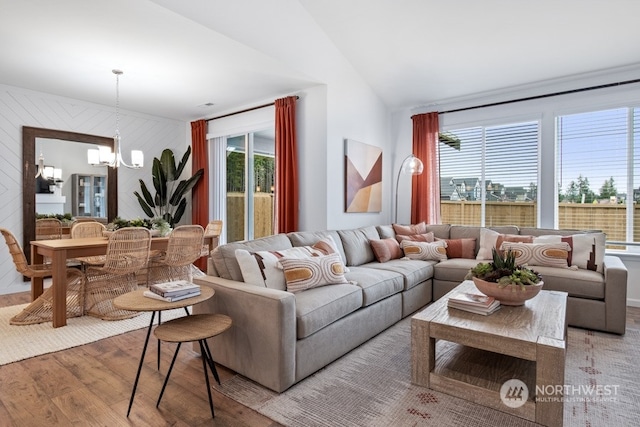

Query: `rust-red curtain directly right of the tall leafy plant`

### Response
(191, 120, 209, 272)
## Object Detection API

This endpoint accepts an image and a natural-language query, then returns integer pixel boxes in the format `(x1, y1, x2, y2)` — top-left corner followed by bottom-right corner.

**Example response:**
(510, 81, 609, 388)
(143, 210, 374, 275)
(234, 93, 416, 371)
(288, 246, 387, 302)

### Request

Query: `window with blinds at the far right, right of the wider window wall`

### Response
(556, 108, 640, 246)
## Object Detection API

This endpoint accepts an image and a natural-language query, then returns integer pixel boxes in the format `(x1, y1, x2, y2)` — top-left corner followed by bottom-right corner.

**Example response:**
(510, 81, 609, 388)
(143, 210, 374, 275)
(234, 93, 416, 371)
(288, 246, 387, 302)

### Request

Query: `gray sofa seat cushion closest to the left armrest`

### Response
(295, 284, 362, 339)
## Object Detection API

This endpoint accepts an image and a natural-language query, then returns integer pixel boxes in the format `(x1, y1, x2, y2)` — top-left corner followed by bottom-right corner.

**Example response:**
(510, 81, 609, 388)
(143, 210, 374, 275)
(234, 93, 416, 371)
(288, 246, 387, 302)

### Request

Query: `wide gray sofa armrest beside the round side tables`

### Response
(193, 276, 296, 392)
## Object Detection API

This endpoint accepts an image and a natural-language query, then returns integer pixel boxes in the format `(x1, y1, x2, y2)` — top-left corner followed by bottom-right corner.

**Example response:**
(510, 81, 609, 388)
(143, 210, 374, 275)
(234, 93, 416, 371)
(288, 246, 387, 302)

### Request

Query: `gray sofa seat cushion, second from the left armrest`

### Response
(345, 266, 405, 307)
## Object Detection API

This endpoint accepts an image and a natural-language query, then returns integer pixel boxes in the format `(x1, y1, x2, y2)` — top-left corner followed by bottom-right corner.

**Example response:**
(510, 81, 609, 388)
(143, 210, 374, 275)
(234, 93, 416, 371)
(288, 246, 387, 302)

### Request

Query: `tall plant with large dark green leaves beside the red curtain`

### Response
(133, 147, 204, 227)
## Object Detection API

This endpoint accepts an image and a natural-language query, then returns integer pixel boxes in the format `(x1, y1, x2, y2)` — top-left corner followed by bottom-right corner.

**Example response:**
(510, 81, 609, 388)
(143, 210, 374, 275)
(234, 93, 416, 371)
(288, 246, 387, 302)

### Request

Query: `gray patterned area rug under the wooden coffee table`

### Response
(215, 318, 640, 427)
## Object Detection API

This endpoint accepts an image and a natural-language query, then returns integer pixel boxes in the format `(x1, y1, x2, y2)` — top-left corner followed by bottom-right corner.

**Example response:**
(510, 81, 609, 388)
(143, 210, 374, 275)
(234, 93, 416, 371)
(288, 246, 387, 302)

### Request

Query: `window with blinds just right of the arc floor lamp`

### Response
(440, 121, 539, 227)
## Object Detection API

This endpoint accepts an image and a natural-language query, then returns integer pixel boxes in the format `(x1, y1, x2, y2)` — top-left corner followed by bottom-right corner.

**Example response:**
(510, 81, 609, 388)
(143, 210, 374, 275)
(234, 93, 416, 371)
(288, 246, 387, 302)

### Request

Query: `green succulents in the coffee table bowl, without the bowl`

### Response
(465, 248, 542, 288)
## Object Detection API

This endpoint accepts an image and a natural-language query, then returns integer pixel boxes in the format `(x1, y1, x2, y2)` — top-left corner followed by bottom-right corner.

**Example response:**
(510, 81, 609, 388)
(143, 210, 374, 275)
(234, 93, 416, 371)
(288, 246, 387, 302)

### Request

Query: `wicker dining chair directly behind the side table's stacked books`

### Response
(147, 225, 204, 285)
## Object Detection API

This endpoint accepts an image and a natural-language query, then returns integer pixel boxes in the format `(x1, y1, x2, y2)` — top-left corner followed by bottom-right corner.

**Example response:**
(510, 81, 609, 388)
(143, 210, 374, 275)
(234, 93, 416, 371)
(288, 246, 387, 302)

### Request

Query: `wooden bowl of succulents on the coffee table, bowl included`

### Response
(465, 248, 544, 305)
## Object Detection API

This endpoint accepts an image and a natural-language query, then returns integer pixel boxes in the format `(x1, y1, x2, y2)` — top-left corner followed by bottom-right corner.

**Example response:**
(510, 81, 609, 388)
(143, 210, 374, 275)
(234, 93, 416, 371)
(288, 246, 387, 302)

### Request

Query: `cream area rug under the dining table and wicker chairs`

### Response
(0, 304, 185, 365)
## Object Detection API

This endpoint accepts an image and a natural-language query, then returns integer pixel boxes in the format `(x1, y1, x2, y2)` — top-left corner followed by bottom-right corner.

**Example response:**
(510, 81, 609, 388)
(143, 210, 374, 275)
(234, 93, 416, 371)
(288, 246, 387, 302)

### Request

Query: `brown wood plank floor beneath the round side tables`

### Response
(0, 292, 280, 427)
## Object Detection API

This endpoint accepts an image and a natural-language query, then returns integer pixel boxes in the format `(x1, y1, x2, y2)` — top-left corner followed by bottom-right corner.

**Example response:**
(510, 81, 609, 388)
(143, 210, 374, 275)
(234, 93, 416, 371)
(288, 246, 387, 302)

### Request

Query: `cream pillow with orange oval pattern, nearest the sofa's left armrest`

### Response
(280, 254, 349, 293)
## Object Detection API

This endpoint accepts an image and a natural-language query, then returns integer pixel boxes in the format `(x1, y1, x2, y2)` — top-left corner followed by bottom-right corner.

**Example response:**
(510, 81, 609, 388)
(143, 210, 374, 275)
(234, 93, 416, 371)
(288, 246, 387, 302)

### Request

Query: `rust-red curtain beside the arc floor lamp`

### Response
(411, 112, 440, 224)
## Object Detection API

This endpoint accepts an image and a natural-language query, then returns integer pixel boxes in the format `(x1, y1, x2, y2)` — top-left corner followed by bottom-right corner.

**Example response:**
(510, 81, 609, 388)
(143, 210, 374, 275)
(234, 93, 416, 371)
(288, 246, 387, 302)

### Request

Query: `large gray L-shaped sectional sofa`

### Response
(194, 225, 627, 392)
